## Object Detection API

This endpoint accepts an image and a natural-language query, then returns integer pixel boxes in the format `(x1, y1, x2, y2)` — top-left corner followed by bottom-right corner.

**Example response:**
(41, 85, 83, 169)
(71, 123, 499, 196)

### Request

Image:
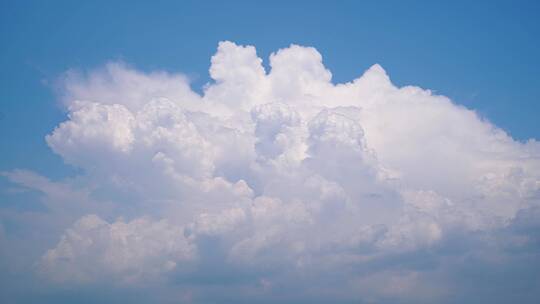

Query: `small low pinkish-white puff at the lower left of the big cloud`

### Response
(41, 215, 196, 283)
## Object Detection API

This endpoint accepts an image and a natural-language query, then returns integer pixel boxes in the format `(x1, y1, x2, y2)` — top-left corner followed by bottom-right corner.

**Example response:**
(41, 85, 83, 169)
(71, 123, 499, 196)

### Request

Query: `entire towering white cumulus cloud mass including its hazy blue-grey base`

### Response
(4, 41, 540, 303)
